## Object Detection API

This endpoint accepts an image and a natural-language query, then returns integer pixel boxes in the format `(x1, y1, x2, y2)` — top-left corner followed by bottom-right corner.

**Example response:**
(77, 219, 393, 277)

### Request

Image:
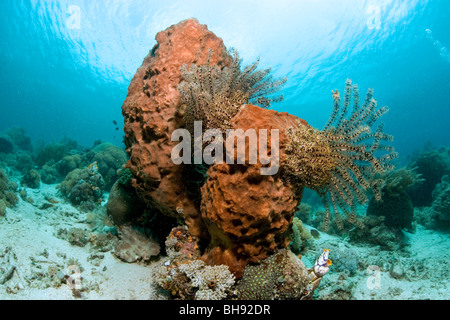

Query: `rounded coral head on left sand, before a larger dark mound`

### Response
(58, 162, 104, 210)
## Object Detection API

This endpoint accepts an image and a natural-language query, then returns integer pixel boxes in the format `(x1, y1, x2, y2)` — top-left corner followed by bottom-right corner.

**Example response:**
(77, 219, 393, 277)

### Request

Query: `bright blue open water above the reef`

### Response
(0, 0, 450, 158)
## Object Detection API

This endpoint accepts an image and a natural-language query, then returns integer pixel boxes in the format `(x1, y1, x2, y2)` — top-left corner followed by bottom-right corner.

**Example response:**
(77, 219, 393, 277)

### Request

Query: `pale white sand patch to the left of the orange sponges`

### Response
(0, 185, 162, 299)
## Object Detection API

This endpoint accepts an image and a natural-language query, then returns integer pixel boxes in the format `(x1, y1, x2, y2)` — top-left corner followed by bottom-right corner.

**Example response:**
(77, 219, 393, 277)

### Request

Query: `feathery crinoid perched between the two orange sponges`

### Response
(178, 50, 286, 133)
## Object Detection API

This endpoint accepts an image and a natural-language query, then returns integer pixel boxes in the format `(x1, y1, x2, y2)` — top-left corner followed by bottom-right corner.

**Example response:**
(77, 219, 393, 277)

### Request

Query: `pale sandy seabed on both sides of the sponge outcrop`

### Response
(0, 184, 450, 300)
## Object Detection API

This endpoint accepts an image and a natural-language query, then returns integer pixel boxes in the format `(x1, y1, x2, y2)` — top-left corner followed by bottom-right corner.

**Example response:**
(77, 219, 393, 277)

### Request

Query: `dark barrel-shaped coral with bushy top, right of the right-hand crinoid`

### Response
(367, 168, 422, 231)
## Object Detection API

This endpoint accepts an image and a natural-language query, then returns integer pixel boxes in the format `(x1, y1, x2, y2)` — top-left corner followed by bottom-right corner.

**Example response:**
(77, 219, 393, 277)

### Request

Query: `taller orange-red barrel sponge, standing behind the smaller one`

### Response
(122, 19, 230, 235)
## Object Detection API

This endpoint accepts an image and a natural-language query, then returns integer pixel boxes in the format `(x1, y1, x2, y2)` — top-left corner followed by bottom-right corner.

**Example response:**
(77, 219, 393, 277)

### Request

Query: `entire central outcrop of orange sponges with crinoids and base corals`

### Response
(116, 19, 396, 299)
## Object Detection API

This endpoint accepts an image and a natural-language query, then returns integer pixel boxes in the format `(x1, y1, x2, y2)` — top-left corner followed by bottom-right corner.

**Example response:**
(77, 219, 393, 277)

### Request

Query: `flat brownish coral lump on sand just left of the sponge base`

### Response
(114, 226, 160, 263)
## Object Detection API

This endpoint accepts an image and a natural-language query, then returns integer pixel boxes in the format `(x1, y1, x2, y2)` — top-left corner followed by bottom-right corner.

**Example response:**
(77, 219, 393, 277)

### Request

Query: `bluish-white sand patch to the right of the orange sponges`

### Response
(302, 225, 450, 300)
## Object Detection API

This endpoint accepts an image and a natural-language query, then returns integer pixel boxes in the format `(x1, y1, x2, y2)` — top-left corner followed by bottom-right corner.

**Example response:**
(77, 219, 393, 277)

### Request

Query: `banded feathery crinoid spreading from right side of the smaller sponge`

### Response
(284, 80, 397, 230)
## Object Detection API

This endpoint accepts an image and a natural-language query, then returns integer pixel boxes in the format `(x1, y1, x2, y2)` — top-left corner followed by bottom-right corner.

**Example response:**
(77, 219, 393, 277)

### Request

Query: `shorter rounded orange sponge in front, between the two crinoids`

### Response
(201, 105, 306, 278)
